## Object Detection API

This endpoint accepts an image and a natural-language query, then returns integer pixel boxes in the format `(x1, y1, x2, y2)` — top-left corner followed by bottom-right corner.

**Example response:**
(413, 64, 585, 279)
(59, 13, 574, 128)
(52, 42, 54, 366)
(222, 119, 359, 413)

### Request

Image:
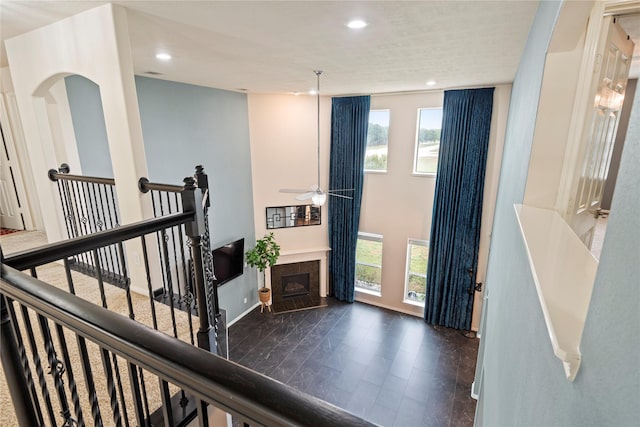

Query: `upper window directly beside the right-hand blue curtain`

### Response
(413, 108, 442, 175)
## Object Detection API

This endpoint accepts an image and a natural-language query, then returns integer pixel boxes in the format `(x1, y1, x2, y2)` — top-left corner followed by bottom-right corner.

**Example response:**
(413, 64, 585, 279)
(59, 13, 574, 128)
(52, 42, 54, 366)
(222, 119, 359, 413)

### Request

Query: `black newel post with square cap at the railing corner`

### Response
(181, 177, 218, 354)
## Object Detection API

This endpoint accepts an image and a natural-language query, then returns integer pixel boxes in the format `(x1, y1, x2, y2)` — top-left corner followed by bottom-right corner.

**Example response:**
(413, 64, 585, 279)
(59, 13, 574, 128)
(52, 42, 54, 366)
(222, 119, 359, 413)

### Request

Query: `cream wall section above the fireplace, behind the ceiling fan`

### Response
(248, 94, 331, 251)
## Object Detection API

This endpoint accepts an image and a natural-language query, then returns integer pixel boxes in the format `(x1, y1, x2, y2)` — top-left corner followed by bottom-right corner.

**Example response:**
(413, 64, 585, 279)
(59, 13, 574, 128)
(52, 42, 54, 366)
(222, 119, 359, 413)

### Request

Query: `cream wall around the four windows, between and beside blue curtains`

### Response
(356, 85, 511, 330)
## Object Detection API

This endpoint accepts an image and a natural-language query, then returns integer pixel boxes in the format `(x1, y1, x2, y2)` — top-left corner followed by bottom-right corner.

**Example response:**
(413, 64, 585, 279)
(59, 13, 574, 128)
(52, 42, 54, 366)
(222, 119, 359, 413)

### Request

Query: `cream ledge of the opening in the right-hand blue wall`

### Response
(514, 205, 598, 381)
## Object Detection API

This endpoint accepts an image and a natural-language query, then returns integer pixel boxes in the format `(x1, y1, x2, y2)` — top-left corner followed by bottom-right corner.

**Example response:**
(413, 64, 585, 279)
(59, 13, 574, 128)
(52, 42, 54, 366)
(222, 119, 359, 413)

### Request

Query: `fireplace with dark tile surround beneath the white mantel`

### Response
(271, 260, 320, 312)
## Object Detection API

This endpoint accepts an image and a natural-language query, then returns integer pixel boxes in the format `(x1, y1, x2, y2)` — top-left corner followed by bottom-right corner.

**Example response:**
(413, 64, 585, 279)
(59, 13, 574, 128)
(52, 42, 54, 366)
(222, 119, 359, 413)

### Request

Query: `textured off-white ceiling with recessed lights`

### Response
(0, 0, 636, 95)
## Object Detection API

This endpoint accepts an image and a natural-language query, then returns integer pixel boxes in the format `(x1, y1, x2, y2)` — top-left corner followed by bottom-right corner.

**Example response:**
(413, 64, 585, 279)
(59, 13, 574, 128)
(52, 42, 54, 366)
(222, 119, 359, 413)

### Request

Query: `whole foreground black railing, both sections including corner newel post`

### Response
(0, 172, 378, 426)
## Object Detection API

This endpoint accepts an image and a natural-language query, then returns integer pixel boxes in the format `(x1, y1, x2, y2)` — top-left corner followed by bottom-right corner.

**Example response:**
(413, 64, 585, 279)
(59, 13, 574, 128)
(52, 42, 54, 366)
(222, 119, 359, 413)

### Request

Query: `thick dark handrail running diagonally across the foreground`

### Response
(0, 264, 373, 427)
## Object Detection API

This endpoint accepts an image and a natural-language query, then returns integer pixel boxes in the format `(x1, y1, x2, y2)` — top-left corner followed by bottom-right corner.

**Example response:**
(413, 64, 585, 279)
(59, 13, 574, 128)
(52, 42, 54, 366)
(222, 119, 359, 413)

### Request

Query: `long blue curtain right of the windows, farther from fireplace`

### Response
(425, 88, 494, 330)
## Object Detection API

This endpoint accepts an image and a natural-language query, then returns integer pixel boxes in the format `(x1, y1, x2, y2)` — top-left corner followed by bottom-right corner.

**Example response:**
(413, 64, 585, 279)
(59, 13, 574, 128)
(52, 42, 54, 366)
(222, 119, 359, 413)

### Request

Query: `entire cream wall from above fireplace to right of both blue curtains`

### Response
(249, 89, 511, 329)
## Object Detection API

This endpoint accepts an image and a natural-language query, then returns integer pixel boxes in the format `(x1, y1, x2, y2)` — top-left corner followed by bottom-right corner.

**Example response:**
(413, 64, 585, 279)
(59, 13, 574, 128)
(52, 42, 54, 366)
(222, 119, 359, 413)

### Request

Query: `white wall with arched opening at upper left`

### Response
(5, 4, 152, 290)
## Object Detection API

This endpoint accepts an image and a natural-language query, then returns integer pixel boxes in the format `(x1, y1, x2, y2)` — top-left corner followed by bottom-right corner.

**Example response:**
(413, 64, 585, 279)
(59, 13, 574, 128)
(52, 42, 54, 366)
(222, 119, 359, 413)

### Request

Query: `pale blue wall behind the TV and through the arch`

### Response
(65, 76, 258, 320)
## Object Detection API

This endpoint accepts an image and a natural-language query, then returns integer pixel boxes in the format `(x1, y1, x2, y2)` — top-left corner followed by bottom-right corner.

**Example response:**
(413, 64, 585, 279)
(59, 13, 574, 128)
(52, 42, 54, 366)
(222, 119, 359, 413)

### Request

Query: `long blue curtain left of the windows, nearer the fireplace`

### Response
(329, 96, 371, 302)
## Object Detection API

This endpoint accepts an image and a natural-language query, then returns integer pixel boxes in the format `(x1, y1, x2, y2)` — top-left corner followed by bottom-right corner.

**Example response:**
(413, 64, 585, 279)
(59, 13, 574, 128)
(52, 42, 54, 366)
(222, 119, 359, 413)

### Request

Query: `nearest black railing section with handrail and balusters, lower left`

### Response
(0, 264, 372, 427)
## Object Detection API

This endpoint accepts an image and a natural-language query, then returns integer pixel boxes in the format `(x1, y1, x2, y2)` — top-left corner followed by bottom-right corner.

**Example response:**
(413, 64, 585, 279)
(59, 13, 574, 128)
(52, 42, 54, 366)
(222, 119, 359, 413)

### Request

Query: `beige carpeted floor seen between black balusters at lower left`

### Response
(0, 231, 198, 427)
